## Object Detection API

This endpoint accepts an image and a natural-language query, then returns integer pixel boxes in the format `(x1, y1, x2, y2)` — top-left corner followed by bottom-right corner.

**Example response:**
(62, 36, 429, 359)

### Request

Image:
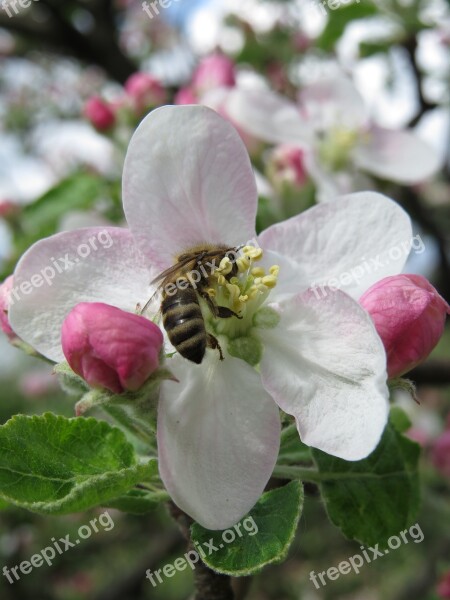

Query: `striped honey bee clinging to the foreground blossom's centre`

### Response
(141, 246, 241, 365)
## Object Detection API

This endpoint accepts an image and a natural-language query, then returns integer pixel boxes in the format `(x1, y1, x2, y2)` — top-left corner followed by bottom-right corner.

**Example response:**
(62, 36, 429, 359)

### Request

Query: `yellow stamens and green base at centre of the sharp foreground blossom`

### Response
(207, 246, 280, 339)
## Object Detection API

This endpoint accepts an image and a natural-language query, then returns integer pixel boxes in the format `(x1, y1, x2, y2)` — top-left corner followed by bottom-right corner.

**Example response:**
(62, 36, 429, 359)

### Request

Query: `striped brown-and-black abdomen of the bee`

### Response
(161, 288, 207, 364)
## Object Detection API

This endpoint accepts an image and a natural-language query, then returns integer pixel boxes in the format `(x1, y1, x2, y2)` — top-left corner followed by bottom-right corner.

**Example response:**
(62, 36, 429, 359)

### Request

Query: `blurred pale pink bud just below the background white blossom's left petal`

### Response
(269, 144, 308, 188)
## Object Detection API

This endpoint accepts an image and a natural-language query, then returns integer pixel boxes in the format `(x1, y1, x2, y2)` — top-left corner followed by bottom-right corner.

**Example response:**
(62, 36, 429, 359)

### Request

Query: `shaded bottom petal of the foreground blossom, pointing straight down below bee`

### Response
(158, 351, 280, 529)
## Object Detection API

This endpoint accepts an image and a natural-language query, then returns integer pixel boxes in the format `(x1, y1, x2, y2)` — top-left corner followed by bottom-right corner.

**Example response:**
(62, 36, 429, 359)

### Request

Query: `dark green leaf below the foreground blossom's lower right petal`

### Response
(313, 424, 420, 547)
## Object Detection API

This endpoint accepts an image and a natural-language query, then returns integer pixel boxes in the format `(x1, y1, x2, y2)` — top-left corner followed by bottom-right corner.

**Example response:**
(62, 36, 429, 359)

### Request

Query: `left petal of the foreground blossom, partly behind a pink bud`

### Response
(9, 227, 156, 362)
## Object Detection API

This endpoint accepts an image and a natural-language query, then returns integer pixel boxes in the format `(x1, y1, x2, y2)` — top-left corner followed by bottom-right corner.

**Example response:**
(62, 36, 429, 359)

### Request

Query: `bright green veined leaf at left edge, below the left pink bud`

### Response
(0, 413, 158, 515)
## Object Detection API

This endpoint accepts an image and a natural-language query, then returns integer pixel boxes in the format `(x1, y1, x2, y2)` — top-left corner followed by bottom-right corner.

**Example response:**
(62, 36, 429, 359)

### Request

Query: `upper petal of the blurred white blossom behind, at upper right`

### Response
(299, 75, 368, 130)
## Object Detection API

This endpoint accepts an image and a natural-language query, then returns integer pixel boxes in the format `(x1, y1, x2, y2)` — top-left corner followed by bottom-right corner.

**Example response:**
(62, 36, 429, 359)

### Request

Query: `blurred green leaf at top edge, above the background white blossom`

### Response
(316, 0, 378, 52)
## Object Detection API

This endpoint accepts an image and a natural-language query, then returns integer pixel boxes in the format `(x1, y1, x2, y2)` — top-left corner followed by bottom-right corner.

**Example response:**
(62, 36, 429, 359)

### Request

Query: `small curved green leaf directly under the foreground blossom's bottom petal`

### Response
(191, 481, 303, 576)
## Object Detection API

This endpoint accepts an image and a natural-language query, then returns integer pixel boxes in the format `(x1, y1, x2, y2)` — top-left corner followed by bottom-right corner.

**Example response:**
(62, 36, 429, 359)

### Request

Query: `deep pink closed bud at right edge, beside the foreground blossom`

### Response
(359, 275, 450, 378)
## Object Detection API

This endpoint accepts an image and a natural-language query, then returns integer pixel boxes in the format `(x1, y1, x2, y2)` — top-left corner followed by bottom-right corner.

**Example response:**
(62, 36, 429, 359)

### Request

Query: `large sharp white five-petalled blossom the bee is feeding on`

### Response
(10, 106, 412, 529)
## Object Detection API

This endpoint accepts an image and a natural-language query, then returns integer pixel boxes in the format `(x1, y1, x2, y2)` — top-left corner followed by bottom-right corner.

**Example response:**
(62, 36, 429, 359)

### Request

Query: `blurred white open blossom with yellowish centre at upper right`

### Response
(209, 74, 441, 200)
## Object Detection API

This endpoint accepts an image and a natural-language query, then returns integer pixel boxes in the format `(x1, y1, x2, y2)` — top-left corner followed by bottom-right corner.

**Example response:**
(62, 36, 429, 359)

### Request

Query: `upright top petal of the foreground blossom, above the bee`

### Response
(123, 106, 257, 268)
